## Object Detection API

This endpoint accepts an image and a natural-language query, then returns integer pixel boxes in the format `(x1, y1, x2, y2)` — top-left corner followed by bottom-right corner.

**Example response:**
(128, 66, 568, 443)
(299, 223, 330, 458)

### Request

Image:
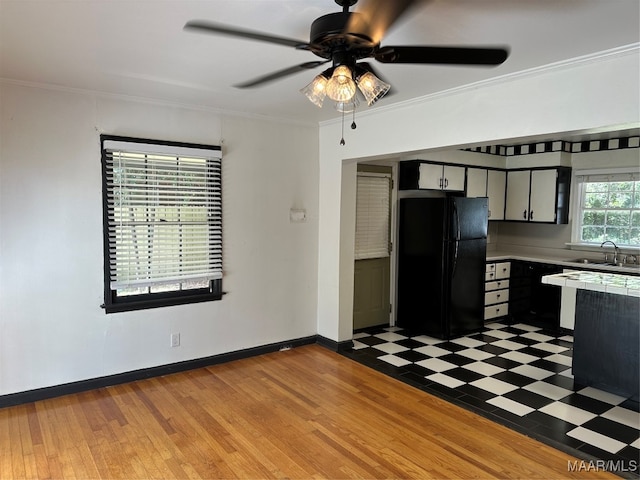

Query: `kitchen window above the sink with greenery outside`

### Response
(573, 170, 640, 246)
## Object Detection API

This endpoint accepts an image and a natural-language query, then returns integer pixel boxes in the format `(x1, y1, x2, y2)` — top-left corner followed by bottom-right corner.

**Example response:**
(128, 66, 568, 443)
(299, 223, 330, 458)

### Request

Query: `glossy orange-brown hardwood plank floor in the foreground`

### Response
(0, 345, 618, 479)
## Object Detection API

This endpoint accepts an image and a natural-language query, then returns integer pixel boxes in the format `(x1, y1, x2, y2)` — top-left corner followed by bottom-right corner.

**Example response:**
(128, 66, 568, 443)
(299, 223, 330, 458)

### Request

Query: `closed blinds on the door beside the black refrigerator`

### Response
(355, 172, 391, 260)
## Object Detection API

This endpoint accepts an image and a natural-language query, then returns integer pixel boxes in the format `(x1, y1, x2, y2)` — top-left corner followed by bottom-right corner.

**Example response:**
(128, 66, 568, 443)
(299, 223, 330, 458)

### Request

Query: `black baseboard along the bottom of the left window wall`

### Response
(0, 335, 318, 408)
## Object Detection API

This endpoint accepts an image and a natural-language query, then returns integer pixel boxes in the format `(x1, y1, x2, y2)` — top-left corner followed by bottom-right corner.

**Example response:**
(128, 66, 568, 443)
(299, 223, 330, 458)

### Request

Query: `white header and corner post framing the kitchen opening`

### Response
(318, 46, 640, 341)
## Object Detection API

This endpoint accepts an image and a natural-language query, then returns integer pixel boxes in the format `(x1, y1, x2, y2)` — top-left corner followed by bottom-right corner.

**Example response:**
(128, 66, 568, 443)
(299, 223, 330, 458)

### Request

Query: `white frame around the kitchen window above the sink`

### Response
(571, 168, 640, 249)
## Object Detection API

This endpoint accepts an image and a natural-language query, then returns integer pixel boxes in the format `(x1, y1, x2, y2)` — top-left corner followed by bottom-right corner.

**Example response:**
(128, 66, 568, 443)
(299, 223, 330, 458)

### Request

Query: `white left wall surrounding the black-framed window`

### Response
(0, 84, 318, 395)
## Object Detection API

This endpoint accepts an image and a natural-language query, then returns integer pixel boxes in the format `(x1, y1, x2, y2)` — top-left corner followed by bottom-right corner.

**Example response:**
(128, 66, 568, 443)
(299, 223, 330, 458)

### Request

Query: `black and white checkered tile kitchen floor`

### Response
(341, 322, 640, 478)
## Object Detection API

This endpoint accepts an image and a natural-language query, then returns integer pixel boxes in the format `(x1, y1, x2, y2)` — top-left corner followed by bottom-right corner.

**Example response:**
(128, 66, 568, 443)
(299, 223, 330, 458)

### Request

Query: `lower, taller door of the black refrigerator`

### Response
(447, 238, 487, 337)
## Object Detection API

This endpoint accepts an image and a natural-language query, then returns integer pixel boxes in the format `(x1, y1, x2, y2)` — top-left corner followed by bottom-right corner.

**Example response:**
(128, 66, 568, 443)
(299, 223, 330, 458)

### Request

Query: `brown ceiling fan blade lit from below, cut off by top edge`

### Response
(345, 0, 425, 43)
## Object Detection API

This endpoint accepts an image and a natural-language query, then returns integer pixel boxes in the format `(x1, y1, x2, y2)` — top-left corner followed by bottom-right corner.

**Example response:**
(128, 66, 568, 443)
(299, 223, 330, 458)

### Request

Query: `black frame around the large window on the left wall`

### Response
(100, 134, 223, 313)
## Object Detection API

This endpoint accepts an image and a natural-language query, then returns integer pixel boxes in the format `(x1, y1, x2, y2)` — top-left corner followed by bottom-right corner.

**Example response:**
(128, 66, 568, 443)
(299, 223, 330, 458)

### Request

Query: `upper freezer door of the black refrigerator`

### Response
(449, 197, 488, 240)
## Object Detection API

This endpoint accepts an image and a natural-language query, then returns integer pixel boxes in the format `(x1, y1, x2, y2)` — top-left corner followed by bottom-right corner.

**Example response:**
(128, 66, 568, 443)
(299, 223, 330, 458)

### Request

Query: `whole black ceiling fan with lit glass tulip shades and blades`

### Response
(184, 0, 508, 141)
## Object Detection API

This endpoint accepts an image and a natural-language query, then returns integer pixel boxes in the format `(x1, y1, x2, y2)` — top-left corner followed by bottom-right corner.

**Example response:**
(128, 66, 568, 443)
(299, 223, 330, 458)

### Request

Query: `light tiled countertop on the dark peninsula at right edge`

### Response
(542, 271, 640, 297)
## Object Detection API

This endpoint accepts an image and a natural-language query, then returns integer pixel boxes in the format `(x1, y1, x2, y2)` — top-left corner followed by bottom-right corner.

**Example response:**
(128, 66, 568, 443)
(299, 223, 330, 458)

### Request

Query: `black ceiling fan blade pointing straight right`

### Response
(374, 46, 509, 65)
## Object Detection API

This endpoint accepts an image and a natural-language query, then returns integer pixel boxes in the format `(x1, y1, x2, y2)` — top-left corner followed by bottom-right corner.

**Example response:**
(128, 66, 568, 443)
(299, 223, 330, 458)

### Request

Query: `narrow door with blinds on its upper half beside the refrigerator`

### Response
(353, 165, 391, 330)
